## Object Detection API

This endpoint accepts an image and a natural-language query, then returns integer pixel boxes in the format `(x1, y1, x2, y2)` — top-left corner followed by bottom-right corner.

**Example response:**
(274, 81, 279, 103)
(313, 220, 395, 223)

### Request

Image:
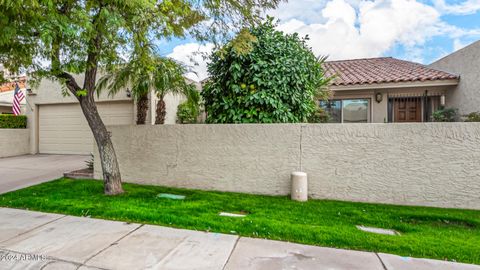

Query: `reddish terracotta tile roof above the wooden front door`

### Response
(325, 57, 459, 86)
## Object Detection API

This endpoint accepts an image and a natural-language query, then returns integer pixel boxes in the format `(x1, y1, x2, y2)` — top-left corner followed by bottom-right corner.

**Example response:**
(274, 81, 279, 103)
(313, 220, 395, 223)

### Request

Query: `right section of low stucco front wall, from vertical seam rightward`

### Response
(302, 123, 480, 209)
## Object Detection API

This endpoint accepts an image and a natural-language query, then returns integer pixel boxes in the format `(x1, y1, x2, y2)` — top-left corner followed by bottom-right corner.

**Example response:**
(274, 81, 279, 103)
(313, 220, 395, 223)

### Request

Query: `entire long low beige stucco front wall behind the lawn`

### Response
(95, 123, 480, 209)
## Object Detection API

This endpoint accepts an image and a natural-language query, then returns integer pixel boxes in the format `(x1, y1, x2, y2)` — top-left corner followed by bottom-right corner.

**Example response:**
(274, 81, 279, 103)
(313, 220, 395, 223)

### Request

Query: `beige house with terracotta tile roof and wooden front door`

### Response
(320, 41, 480, 123)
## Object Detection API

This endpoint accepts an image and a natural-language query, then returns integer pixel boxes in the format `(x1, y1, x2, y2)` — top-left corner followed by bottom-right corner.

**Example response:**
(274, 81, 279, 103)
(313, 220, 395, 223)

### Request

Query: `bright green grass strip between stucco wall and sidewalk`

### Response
(0, 179, 480, 264)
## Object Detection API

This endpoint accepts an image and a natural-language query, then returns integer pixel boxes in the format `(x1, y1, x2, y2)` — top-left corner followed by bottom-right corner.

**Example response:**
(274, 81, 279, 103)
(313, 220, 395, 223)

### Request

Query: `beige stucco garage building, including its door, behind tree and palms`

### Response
(26, 75, 199, 154)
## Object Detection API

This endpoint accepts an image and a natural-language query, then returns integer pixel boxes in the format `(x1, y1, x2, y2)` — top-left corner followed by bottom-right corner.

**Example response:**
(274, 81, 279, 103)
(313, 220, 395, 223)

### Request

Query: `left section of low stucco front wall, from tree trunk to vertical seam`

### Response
(95, 125, 300, 194)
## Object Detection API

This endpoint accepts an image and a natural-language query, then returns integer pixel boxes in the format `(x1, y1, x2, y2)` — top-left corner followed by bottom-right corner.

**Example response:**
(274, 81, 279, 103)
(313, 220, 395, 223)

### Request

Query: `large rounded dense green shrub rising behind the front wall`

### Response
(202, 18, 329, 123)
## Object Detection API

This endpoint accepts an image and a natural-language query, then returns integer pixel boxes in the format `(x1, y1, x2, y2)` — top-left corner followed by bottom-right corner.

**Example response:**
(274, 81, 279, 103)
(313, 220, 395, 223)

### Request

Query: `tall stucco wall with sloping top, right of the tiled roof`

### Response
(430, 41, 480, 115)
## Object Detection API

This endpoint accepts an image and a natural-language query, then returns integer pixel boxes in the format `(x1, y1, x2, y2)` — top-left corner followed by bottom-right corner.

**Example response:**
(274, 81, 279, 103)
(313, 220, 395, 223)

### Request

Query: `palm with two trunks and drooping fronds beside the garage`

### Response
(98, 56, 191, 124)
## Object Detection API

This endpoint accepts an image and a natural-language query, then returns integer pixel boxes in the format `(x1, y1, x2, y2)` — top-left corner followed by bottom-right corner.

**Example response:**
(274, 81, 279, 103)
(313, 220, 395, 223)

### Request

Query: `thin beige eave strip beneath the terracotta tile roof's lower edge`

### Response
(329, 79, 459, 91)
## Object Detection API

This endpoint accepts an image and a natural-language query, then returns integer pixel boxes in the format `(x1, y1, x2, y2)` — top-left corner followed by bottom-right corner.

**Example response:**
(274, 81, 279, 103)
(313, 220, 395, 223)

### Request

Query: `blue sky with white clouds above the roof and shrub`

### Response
(161, 0, 480, 81)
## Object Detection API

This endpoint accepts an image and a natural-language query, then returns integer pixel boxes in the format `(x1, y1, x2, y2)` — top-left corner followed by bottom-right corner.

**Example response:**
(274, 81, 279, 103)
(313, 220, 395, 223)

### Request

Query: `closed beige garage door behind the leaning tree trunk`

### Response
(39, 102, 134, 154)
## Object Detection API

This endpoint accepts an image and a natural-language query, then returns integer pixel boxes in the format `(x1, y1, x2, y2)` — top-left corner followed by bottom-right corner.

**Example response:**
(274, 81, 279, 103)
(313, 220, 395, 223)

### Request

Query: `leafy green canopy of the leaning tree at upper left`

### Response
(0, 0, 281, 86)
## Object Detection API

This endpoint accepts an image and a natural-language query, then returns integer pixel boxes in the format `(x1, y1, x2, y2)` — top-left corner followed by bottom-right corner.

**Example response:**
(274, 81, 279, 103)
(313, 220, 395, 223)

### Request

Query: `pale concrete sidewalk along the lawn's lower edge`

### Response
(0, 208, 480, 270)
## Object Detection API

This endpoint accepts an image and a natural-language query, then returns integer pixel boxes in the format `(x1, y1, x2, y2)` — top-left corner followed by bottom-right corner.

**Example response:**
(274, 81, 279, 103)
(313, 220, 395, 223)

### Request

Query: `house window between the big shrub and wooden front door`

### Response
(320, 99, 370, 123)
